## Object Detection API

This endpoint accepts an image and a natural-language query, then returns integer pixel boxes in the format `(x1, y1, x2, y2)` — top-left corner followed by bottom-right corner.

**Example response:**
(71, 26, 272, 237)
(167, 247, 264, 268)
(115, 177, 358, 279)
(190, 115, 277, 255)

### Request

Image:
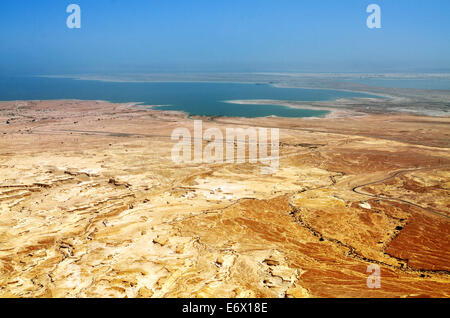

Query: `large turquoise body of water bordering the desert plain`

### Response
(0, 77, 375, 118)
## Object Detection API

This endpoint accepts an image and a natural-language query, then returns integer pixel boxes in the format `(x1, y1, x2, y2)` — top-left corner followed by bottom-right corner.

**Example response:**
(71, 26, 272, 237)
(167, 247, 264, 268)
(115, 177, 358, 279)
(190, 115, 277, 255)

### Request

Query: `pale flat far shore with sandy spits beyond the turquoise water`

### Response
(30, 72, 450, 117)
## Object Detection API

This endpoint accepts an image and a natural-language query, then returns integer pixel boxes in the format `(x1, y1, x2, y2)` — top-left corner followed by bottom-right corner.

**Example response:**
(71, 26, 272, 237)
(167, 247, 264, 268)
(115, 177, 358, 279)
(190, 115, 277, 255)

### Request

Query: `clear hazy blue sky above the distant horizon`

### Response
(0, 0, 450, 74)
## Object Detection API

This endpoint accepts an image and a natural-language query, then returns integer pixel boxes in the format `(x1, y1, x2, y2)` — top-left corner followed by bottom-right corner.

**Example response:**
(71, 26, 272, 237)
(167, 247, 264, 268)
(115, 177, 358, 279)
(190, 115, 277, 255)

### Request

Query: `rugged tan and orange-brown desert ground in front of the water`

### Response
(0, 101, 450, 297)
